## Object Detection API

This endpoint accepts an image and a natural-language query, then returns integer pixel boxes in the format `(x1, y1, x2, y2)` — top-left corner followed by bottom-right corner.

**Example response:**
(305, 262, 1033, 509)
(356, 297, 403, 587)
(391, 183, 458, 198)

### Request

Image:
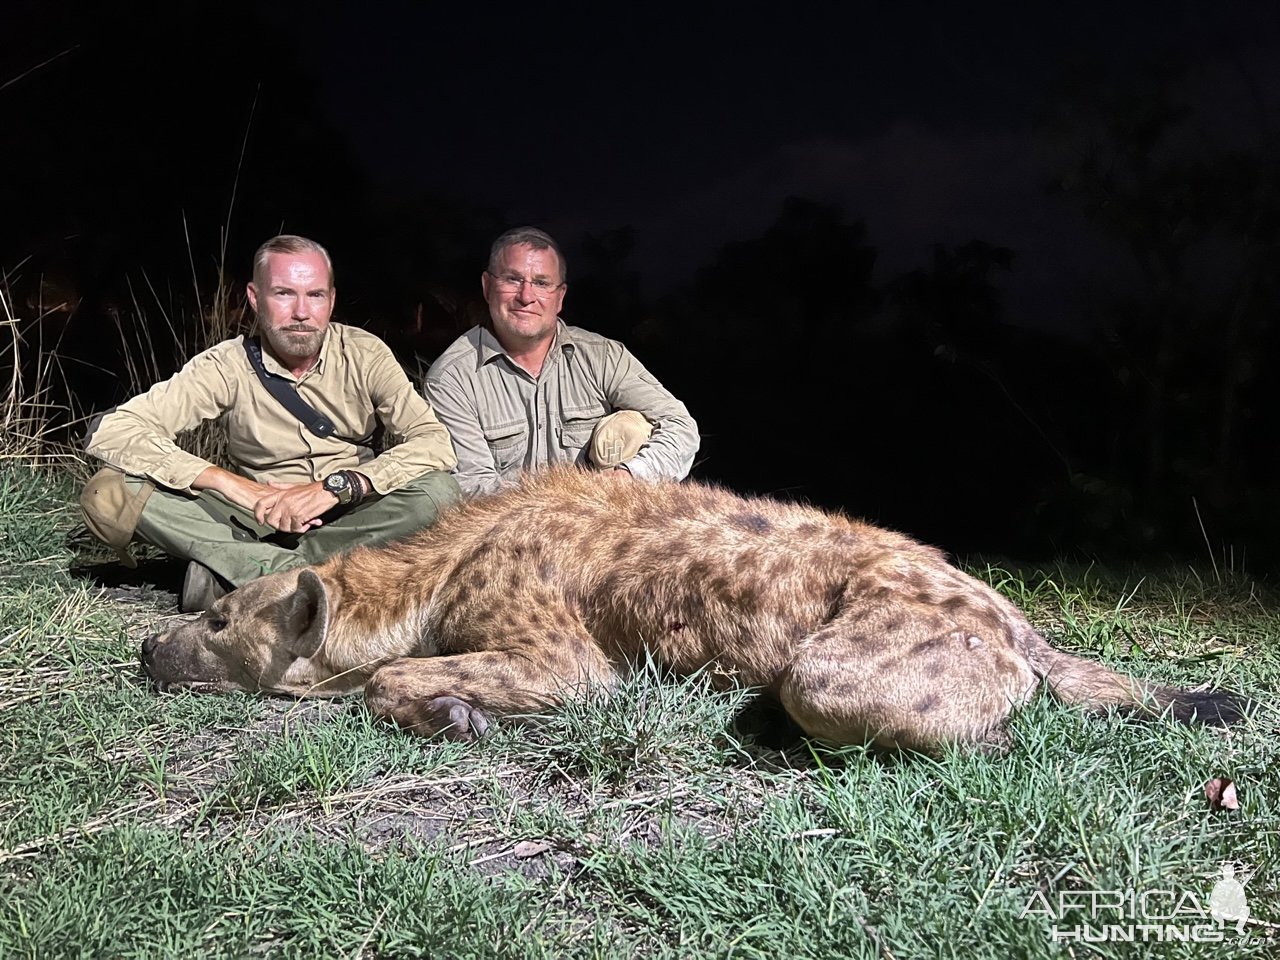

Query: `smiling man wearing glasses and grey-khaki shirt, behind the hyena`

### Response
(425, 227, 698, 495)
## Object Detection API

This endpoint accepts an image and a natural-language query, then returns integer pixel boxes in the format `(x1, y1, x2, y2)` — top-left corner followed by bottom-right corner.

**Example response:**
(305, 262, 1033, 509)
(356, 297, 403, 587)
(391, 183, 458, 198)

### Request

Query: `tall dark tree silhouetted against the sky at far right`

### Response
(1047, 58, 1280, 555)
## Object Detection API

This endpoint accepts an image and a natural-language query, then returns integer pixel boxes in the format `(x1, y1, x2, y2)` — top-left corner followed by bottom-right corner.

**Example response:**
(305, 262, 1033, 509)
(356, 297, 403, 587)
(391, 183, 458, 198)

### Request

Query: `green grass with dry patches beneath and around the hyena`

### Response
(0, 463, 1280, 960)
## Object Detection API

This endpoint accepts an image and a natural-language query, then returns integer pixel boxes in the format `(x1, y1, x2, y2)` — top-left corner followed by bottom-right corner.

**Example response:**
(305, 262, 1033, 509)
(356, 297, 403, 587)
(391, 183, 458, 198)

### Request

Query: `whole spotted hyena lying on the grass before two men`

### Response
(142, 467, 1243, 749)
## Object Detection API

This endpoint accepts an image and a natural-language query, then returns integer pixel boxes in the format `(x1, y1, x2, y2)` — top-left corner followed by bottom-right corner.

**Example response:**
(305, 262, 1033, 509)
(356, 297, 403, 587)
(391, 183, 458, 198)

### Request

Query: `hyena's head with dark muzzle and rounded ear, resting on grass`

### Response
(142, 568, 329, 692)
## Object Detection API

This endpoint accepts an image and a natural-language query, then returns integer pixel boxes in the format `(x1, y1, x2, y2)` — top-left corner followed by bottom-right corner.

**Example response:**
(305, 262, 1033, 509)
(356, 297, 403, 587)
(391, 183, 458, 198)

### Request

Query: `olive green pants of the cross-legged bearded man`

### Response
(111, 471, 462, 586)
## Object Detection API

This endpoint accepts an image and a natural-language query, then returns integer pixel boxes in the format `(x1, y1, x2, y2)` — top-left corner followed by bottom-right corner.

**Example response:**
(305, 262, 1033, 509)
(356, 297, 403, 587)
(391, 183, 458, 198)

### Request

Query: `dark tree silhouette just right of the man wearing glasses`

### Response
(666, 197, 878, 504)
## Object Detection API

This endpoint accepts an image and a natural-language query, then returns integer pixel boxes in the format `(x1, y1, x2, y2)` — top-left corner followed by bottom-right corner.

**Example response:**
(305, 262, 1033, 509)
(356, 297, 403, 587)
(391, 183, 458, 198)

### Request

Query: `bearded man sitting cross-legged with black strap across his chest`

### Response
(81, 236, 460, 612)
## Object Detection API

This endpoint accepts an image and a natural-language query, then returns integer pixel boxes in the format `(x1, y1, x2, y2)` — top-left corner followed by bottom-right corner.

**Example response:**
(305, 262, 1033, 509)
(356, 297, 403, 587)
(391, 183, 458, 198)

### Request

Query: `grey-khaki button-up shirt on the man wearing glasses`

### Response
(424, 321, 699, 494)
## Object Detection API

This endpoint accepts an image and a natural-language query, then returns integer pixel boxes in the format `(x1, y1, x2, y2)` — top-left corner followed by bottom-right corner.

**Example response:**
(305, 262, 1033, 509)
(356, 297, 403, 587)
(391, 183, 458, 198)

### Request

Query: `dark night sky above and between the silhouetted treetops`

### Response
(290, 0, 1280, 326)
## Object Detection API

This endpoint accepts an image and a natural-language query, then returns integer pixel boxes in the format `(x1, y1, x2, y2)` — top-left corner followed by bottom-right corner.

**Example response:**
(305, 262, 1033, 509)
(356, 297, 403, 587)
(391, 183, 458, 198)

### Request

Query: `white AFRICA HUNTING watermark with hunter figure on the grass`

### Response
(1019, 863, 1270, 943)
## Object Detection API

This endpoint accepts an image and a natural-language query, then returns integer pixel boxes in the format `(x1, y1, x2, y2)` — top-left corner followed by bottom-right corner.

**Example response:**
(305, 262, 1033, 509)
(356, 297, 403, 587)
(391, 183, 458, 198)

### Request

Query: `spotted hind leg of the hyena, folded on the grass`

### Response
(778, 620, 1036, 753)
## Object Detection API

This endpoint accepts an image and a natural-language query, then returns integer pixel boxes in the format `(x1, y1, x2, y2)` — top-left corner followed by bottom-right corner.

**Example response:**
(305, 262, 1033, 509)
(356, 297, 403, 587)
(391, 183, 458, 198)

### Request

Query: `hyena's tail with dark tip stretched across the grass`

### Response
(1019, 627, 1254, 727)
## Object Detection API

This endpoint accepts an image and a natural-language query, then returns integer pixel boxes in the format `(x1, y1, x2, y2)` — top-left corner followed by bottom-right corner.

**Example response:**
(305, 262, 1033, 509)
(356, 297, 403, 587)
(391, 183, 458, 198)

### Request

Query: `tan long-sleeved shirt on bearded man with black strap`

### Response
(84, 323, 457, 494)
